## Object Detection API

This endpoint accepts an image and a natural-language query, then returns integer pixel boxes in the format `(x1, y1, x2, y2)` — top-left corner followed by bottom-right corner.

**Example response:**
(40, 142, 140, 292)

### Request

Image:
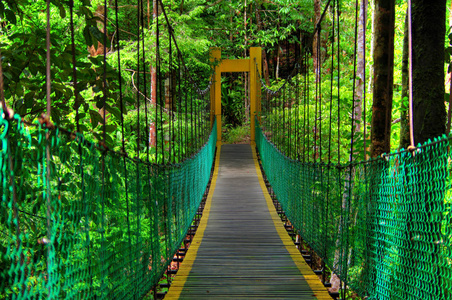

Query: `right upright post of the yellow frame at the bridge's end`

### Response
(249, 47, 262, 146)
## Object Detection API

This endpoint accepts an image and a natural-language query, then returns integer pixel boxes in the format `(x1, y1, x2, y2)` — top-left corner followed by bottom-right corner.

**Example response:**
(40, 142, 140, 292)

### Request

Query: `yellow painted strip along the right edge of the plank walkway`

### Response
(252, 147, 331, 300)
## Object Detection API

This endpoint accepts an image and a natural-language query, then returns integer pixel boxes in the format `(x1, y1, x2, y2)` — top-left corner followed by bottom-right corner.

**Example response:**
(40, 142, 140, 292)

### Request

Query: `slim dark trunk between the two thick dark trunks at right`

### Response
(399, 13, 410, 149)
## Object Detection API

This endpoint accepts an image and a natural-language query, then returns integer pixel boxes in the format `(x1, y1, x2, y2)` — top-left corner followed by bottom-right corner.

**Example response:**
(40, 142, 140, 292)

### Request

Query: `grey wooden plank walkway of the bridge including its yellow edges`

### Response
(165, 145, 331, 299)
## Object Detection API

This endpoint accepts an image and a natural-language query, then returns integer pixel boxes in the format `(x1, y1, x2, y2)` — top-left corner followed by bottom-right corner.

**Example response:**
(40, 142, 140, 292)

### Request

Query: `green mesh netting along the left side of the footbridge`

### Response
(0, 115, 216, 299)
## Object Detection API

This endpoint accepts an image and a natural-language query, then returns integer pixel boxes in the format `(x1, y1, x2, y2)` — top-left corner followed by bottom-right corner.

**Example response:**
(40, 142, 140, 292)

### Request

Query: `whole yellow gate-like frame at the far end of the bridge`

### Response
(210, 47, 262, 146)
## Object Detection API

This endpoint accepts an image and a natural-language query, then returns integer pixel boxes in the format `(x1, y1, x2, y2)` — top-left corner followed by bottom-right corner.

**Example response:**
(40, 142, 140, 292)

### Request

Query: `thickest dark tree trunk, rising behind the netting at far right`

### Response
(412, 0, 446, 144)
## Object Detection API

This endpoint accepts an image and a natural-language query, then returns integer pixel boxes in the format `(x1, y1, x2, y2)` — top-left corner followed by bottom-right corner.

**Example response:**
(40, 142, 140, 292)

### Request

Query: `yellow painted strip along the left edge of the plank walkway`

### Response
(165, 145, 221, 299)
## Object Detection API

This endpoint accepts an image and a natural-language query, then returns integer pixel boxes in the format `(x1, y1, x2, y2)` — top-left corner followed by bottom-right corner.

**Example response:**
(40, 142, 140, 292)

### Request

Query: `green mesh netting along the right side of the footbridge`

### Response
(256, 122, 452, 300)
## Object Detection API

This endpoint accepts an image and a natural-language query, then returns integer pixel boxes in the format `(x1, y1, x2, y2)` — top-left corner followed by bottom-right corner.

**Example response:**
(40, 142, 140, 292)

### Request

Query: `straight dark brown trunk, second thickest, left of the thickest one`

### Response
(371, 0, 395, 157)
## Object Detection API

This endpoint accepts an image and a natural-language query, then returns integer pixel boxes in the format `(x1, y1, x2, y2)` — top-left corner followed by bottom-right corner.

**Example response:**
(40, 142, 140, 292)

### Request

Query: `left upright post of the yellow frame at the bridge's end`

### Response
(210, 48, 221, 145)
